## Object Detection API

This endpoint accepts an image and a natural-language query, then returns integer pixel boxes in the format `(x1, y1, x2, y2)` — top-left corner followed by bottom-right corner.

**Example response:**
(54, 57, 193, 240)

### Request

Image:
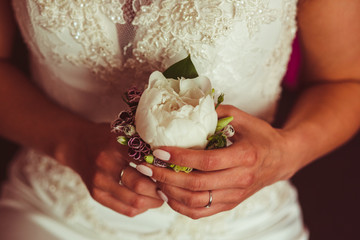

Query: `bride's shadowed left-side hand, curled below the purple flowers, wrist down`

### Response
(55, 124, 163, 217)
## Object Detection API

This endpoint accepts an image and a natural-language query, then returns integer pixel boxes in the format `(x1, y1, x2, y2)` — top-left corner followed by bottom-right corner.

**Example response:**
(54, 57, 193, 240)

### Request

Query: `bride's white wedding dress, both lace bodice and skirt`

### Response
(0, 0, 308, 240)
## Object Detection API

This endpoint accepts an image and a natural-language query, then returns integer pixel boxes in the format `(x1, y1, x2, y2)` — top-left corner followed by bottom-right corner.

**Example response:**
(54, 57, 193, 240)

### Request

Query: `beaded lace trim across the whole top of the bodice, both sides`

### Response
(33, 0, 278, 81)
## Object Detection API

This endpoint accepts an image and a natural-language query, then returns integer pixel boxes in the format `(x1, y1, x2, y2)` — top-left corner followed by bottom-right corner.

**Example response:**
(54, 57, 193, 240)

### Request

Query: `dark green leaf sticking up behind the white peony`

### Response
(163, 55, 199, 79)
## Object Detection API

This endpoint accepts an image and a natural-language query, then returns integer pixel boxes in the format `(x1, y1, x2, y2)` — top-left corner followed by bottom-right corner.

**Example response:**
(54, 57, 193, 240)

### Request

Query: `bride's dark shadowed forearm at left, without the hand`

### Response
(0, 61, 94, 160)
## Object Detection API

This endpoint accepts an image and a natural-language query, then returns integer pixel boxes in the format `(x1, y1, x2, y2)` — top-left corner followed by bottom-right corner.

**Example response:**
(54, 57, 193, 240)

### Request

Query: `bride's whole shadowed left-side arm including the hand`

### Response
(0, 3, 163, 216)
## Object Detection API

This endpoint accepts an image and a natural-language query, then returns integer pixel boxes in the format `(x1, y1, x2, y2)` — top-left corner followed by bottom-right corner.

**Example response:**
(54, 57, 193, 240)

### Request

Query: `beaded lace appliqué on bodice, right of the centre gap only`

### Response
(127, 0, 278, 70)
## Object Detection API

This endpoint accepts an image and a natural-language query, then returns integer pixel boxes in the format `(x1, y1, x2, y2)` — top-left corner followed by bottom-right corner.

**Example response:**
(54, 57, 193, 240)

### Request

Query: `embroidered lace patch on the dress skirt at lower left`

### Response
(19, 151, 115, 235)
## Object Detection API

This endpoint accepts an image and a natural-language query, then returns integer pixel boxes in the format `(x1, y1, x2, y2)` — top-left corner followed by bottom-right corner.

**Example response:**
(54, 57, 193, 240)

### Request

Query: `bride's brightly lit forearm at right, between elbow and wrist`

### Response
(283, 81, 360, 172)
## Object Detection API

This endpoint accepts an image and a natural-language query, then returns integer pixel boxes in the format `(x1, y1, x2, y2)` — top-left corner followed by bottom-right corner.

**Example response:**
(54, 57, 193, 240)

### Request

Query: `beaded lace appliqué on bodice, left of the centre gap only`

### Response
(34, 0, 150, 81)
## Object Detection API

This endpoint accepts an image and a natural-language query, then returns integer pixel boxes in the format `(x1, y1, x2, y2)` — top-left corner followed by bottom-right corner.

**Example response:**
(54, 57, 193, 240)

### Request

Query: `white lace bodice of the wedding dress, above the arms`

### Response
(14, 0, 296, 121)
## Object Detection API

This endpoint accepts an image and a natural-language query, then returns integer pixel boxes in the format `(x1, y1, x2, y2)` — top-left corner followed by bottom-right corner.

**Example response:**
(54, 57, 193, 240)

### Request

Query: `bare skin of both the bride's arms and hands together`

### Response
(0, 0, 360, 219)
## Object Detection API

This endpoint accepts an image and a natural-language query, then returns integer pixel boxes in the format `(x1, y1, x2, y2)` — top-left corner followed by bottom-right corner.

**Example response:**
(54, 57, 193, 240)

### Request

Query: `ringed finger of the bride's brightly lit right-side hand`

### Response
(159, 184, 246, 208)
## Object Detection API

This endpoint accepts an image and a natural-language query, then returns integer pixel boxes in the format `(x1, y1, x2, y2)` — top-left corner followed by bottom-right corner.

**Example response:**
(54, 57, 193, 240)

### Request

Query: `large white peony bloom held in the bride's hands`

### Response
(135, 71, 217, 149)
